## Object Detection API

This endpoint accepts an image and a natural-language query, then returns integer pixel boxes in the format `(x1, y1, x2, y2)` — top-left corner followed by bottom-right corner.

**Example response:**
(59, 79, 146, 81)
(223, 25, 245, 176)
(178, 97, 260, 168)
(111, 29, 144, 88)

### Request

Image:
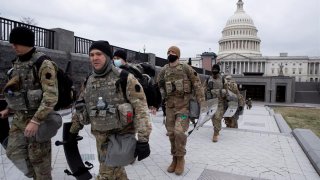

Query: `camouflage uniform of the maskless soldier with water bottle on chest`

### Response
(70, 63, 152, 179)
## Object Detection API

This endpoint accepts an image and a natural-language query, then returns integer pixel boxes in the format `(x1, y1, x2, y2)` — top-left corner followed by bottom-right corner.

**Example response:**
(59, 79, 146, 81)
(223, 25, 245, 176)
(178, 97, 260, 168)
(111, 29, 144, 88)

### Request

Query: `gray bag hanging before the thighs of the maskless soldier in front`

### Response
(105, 134, 137, 167)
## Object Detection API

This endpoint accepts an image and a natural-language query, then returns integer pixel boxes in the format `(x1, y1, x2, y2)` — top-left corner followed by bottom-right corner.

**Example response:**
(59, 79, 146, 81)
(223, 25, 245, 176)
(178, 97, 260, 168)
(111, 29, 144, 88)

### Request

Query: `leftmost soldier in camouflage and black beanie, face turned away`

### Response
(0, 27, 58, 180)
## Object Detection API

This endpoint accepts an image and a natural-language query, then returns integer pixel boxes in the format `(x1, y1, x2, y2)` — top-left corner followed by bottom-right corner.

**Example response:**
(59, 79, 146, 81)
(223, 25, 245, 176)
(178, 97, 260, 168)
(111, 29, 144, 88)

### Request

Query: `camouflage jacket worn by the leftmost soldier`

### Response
(4, 48, 58, 122)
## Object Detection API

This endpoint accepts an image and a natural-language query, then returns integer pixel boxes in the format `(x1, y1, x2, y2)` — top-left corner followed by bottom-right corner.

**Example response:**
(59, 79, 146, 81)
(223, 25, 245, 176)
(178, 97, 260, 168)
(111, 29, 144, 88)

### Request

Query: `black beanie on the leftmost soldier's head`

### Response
(9, 27, 34, 47)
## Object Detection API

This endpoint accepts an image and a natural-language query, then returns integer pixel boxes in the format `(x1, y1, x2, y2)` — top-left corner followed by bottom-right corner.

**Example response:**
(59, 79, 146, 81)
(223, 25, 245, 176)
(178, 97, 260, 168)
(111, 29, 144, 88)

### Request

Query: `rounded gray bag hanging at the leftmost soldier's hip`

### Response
(36, 111, 62, 143)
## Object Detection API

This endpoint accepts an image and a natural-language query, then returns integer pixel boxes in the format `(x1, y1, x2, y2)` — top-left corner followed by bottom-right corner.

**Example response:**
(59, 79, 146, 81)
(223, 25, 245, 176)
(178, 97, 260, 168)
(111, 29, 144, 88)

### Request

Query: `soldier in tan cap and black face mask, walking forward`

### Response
(157, 46, 205, 175)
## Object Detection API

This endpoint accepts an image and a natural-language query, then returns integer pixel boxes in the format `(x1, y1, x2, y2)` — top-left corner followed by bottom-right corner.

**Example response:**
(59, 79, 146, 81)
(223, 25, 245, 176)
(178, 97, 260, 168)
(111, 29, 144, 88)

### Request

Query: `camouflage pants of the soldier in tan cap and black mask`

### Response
(166, 107, 190, 156)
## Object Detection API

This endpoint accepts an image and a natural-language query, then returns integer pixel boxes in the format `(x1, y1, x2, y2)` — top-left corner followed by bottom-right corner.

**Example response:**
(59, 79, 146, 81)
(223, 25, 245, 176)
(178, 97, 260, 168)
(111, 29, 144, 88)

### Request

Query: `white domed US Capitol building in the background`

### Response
(181, 0, 320, 103)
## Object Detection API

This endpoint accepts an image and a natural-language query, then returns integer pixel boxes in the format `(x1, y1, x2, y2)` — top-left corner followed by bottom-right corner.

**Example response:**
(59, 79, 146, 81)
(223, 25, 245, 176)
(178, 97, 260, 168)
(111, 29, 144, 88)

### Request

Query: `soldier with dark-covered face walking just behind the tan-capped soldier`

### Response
(205, 64, 226, 142)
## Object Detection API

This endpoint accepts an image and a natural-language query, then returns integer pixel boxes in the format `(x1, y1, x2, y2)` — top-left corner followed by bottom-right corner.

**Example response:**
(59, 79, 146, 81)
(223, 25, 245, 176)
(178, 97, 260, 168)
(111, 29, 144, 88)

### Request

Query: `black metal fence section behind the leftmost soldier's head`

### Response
(0, 17, 54, 49)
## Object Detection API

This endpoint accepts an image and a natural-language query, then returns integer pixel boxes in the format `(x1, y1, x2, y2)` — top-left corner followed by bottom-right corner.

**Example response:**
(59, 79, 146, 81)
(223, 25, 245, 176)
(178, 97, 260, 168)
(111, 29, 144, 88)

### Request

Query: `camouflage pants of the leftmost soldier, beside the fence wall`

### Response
(7, 124, 52, 180)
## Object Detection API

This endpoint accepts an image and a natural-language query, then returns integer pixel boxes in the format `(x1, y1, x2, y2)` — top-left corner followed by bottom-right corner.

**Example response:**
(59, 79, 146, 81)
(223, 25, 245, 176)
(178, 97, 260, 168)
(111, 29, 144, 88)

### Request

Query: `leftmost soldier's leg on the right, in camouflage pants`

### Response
(28, 138, 52, 180)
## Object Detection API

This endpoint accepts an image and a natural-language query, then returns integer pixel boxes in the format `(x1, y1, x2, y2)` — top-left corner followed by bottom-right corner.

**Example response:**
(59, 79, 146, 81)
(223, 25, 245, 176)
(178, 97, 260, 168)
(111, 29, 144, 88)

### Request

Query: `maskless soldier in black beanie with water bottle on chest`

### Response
(70, 41, 151, 180)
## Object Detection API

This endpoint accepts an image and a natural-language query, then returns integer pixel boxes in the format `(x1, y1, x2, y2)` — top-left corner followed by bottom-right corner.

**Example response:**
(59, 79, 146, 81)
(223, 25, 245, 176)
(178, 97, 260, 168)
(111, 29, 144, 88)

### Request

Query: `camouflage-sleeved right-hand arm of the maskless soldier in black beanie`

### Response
(126, 74, 152, 142)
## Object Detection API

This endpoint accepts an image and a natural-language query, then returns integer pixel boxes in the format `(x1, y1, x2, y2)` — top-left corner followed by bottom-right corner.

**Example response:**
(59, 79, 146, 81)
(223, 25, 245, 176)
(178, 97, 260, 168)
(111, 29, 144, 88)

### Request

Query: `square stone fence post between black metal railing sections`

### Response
(51, 28, 75, 53)
